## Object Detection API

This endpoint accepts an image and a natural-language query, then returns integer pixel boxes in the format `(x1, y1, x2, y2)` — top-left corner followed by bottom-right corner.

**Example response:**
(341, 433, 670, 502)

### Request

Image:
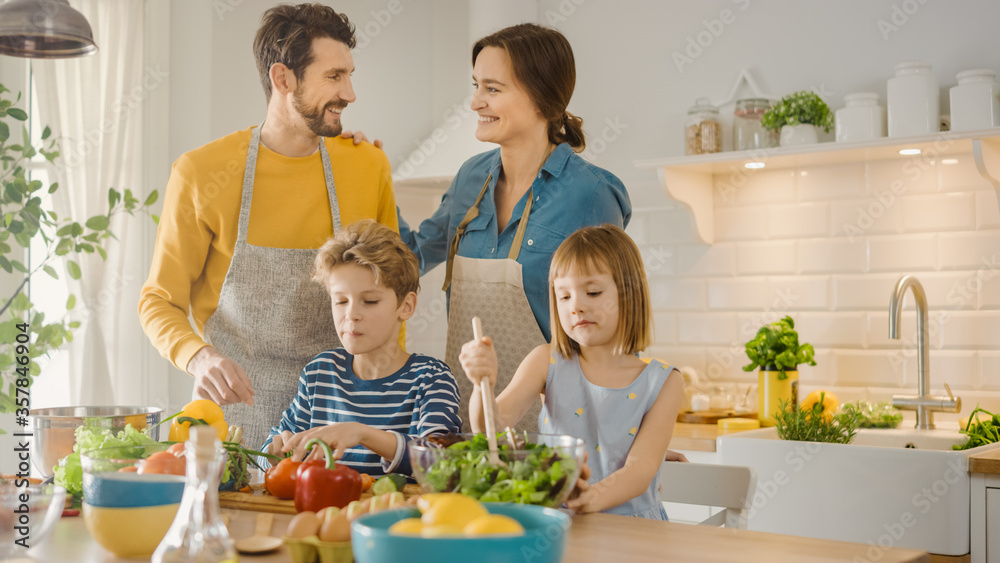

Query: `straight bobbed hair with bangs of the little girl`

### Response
(549, 224, 653, 359)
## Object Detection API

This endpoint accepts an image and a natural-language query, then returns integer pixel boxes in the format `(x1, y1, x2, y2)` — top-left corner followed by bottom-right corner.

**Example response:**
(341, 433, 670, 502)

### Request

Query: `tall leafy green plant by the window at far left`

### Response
(0, 84, 159, 433)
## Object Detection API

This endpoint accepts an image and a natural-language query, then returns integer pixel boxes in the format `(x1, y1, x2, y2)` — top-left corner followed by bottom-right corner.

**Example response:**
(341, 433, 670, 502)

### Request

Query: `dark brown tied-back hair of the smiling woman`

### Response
(472, 23, 587, 152)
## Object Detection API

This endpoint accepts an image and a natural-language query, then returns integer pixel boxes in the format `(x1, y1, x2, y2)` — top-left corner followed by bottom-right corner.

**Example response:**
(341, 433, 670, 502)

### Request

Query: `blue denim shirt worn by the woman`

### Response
(397, 143, 632, 341)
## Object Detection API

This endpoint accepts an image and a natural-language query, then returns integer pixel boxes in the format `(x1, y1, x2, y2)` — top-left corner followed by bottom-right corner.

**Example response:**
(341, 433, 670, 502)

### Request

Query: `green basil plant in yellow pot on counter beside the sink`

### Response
(743, 315, 816, 426)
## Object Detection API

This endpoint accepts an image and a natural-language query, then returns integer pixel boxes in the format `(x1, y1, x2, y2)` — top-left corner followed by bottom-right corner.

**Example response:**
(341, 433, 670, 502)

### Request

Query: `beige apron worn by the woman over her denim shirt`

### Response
(444, 175, 545, 432)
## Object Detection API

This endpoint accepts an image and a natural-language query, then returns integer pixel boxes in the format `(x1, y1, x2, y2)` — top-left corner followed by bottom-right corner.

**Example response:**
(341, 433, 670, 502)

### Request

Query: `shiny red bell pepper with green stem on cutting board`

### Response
(295, 438, 361, 512)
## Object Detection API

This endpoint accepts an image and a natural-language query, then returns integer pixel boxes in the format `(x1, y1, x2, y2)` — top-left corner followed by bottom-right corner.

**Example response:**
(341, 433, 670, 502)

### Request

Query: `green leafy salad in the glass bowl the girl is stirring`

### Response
(425, 434, 577, 506)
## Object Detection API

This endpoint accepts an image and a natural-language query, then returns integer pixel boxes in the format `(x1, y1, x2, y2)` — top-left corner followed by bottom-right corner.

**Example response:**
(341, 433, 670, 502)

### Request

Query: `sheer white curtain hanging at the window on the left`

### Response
(32, 0, 150, 405)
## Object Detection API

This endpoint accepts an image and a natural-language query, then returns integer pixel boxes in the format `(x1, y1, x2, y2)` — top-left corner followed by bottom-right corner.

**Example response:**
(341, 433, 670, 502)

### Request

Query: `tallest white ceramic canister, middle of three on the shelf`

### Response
(886, 61, 940, 137)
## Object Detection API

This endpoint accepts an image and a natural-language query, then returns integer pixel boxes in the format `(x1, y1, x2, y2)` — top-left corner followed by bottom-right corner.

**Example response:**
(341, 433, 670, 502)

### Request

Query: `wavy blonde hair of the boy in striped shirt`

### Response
(312, 219, 420, 303)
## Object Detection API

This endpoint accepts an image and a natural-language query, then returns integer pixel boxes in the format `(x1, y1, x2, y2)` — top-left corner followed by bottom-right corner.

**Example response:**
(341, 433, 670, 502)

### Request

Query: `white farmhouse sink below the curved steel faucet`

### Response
(718, 428, 1000, 561)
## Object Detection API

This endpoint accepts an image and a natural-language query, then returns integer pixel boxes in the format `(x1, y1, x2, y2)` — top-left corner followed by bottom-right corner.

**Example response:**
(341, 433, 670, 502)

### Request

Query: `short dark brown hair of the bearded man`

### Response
(253, 4, 357, 102)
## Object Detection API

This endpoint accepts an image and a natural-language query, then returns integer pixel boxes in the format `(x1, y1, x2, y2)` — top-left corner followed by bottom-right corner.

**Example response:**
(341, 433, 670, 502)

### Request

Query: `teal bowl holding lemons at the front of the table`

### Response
(351, 502, 570, 563)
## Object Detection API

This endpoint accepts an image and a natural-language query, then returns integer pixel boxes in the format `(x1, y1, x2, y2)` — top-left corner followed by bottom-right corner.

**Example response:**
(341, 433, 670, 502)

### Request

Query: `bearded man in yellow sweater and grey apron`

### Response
(139, 4, 398, 446)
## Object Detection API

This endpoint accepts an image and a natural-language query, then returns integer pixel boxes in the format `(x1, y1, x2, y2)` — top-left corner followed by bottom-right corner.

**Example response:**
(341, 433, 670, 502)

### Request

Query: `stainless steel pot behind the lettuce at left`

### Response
(28, 406, 163, 477)
